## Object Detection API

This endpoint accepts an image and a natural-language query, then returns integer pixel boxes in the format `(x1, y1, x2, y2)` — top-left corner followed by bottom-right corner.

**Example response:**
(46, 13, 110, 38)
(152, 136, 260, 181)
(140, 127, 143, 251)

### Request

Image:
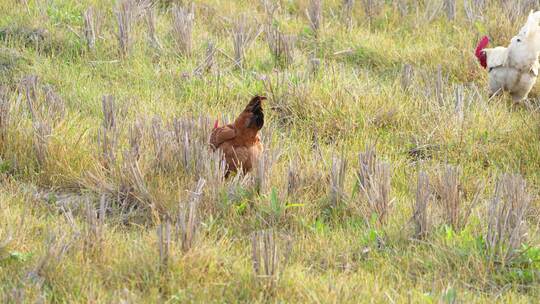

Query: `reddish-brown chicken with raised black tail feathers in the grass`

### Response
(210, 96, 266, 176)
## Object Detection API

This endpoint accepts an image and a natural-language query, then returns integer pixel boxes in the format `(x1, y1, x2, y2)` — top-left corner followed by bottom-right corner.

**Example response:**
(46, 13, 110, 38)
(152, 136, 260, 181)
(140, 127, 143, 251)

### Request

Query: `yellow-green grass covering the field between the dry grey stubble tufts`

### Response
(0, 0, 540, 303)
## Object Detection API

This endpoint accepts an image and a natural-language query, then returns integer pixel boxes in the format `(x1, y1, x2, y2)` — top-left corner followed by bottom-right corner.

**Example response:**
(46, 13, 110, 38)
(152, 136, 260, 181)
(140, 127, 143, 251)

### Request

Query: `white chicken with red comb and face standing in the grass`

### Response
(476, 11, 540, 101)
